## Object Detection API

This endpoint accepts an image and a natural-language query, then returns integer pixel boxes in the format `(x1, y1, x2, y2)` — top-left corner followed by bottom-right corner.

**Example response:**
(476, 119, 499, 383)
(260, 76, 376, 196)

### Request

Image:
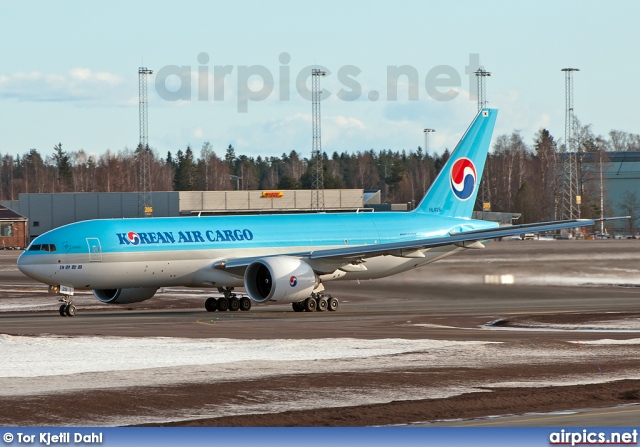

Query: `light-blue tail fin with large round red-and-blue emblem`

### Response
(415, 109, 498, 218)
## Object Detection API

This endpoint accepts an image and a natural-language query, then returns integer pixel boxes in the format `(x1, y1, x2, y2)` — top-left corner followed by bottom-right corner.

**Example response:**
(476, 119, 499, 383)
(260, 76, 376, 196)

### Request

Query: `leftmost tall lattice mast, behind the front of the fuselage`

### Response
(138, 67, 153, 217)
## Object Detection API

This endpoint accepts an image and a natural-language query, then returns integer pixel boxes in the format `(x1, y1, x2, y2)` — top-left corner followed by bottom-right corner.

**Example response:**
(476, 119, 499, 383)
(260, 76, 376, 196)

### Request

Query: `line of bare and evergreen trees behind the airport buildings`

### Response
(0, 122, 640, 226)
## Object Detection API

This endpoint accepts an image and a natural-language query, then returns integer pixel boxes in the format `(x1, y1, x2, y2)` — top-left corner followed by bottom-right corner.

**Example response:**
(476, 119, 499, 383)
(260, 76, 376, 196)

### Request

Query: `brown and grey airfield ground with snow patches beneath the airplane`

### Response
(0, 240, 640, 426)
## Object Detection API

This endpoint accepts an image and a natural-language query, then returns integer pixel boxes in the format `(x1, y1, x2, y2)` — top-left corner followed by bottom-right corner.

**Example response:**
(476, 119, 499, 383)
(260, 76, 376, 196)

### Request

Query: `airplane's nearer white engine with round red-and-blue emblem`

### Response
(244, 256, 319, 303)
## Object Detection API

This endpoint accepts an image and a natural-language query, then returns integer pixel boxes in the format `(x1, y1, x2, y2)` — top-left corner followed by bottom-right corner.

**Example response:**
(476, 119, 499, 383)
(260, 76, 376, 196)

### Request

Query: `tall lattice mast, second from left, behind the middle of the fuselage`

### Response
(311, 68, 327, 211)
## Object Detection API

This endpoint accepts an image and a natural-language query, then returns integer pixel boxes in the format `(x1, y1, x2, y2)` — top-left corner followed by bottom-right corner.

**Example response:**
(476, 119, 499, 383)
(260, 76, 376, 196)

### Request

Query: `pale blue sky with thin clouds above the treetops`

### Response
(0, 0, 640, 157)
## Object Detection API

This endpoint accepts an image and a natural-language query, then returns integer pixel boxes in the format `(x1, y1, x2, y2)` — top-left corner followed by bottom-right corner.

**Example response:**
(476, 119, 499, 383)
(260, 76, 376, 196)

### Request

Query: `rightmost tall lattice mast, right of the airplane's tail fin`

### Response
(560, 68, 581, 220)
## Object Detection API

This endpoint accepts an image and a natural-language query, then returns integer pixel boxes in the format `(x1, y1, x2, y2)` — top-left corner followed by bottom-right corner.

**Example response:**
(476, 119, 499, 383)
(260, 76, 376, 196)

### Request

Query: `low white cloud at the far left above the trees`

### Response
(0, 67, 127, 103)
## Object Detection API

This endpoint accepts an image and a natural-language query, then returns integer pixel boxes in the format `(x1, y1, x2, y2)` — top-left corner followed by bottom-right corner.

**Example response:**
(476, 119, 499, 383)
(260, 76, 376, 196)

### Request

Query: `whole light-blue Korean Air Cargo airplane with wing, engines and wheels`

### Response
(18, 109, 616, 316)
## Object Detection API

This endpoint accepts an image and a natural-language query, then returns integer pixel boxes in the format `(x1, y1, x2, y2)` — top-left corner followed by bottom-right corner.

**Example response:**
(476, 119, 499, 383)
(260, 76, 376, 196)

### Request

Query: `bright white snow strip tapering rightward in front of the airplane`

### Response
(0, 335, 487, 378)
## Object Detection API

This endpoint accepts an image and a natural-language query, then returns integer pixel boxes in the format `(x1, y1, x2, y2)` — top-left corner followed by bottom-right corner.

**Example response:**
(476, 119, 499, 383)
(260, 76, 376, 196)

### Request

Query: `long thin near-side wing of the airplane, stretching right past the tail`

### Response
(225, 217, 628, 269)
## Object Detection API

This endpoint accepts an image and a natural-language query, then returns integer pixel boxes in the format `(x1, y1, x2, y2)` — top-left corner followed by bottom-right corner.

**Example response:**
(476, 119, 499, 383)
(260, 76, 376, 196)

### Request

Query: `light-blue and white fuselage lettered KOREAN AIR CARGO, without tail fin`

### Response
(13, 212, 497, 289)
